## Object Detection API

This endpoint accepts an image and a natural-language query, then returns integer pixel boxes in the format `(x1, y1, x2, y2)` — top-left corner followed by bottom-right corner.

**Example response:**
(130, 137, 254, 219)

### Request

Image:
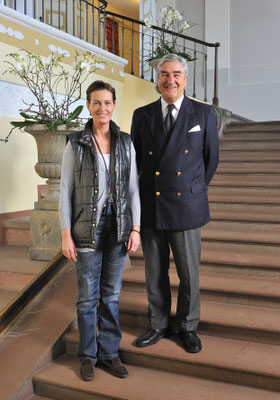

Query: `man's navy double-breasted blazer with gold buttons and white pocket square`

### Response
(131, 96, 219, 230)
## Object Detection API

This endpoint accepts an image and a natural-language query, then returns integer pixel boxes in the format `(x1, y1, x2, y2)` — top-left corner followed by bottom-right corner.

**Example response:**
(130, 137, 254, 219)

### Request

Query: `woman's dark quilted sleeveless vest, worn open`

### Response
(69, 119, 132, 248)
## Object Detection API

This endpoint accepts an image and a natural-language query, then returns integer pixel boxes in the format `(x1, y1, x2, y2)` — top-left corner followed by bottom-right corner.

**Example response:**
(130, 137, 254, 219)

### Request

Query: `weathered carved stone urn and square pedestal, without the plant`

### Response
(24, 124, 82, 260)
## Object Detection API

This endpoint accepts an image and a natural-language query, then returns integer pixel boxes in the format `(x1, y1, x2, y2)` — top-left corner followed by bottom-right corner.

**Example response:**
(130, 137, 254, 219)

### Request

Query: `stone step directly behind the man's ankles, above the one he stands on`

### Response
(119, 292, 280, 345)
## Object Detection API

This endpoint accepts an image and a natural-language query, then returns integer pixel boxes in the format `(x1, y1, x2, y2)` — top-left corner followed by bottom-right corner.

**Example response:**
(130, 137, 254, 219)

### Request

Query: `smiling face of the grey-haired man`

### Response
(157, 61, 188, 104)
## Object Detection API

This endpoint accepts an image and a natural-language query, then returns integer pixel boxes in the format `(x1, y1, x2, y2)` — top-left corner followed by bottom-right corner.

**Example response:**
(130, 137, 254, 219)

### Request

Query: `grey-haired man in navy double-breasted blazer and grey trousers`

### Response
(131, 54, 219, 353)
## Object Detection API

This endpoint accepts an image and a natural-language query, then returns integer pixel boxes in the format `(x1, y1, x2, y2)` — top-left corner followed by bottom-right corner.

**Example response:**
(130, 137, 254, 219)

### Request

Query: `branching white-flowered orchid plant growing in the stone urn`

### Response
(0, 50, 104, 142)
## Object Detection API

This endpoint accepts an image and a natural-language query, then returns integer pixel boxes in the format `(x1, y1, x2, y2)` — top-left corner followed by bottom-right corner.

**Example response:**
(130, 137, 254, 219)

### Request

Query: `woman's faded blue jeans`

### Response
(76, 213, 126, 364)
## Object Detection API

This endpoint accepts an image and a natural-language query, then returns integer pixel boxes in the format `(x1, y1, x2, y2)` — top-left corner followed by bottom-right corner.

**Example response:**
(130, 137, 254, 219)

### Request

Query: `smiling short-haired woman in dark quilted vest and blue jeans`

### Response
(59, 81, 140, 380)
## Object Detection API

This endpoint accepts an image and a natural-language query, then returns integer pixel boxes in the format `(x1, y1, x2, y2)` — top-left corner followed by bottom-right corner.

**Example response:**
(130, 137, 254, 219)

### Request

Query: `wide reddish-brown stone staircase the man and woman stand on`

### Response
(25, 123, 280, 400)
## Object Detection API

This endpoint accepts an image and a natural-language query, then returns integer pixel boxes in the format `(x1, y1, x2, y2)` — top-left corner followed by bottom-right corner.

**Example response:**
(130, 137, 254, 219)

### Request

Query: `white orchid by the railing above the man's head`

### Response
(144, 6, 197, 61)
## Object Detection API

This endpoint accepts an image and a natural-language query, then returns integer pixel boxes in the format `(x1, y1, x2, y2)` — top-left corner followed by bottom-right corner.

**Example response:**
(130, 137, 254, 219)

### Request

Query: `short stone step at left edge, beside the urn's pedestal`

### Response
(3, 216, 31, 247)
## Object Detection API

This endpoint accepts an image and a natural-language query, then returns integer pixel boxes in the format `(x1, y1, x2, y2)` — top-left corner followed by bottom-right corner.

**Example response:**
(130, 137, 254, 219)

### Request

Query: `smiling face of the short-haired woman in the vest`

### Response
(87, 89, 116, 124)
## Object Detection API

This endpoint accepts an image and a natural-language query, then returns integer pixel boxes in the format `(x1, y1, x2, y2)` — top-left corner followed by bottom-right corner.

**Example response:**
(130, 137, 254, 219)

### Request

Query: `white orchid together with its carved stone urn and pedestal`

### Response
(0, 50, 104, 260)
